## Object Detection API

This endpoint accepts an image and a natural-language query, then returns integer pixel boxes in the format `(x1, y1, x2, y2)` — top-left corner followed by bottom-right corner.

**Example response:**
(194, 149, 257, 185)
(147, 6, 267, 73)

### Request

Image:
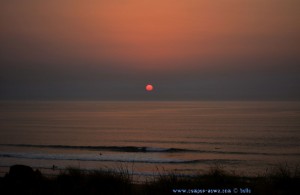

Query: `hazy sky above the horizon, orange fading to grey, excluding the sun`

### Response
(0, 0, 300, 100)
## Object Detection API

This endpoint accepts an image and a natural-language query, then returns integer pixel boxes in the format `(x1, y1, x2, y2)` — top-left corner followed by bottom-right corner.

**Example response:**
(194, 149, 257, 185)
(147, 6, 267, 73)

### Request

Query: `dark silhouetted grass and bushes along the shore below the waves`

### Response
(0, 165, 300, 195)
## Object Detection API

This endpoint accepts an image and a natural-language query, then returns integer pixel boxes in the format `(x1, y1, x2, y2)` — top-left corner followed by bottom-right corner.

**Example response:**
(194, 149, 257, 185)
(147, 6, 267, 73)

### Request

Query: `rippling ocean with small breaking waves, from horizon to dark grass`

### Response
(0, 101, 300, 179)
